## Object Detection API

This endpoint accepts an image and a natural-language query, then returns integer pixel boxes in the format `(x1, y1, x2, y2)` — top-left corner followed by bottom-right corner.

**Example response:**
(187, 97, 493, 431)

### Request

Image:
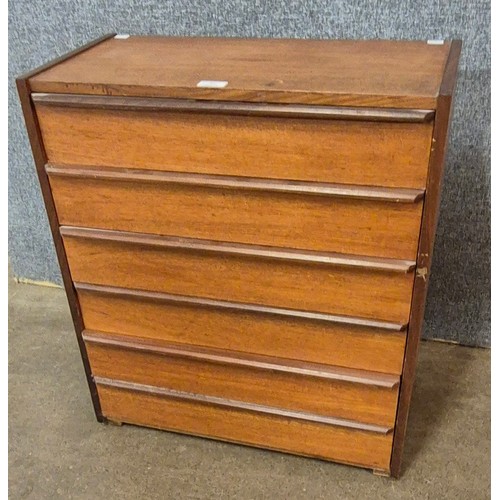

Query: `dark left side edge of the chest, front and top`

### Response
(16, 33, 114, 422)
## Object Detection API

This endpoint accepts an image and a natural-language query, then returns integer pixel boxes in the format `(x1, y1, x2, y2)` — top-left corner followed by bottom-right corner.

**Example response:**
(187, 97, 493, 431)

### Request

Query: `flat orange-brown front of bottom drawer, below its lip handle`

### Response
(97, 384, 393, 470)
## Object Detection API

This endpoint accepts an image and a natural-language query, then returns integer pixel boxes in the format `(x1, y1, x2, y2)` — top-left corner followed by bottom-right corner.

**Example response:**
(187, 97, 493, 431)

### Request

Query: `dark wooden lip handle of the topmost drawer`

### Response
(31, 92, 435, 123)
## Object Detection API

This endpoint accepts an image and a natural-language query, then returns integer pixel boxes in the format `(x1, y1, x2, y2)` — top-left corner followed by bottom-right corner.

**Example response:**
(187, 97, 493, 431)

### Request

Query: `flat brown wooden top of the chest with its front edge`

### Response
(30, 36, 451, 109)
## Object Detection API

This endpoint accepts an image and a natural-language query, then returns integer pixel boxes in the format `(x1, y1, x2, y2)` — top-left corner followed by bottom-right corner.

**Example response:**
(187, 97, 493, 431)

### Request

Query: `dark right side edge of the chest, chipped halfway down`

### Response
(391, 40, 462, 478)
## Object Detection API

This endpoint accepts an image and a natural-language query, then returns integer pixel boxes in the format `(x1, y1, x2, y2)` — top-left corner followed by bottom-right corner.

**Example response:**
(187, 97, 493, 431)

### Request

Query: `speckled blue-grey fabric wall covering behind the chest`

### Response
(9, 0, 490, 346)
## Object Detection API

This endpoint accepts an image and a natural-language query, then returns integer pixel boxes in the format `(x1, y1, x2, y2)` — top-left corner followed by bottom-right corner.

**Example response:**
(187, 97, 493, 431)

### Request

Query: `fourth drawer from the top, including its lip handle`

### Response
(75, 283, 406, 375)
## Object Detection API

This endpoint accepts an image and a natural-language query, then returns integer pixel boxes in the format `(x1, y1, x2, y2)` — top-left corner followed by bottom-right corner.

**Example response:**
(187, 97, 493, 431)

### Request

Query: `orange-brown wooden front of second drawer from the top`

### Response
(48, 167, 422, 260)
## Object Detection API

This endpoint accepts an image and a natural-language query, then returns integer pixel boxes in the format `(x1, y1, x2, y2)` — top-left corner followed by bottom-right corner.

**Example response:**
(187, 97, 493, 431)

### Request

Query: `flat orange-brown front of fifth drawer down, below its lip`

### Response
(86, 337, 398, 430)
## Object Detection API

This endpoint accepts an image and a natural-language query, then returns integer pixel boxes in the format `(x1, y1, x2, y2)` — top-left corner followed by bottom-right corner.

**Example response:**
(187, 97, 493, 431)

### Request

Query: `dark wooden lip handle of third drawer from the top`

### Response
(59, 226, 416, 273)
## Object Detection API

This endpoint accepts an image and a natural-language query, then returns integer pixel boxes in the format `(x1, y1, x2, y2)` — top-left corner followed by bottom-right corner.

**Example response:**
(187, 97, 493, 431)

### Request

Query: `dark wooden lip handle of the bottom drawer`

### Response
(94, 376, 393, 435)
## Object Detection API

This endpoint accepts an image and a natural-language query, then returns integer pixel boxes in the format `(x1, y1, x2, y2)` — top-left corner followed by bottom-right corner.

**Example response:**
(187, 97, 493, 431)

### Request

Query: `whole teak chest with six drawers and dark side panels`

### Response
(17, 35, 460, 476)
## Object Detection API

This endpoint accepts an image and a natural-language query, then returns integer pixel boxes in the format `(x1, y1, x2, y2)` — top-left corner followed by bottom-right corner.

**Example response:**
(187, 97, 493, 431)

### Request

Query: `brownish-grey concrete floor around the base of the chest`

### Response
(9, 283, 490, 500)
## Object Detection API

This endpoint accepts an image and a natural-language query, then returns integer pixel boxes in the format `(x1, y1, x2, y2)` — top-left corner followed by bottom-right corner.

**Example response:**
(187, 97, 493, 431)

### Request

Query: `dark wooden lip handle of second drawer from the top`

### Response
(45, 163, 425, 203)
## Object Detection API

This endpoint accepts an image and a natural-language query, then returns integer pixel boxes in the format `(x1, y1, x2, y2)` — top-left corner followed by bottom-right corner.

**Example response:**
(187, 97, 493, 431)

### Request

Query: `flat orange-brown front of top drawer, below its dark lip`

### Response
(36, 103, 433, 188)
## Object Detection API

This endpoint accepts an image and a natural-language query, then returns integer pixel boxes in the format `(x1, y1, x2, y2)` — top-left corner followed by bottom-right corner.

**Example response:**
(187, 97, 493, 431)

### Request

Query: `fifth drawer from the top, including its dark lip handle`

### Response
(84, 333, 399, 426)
